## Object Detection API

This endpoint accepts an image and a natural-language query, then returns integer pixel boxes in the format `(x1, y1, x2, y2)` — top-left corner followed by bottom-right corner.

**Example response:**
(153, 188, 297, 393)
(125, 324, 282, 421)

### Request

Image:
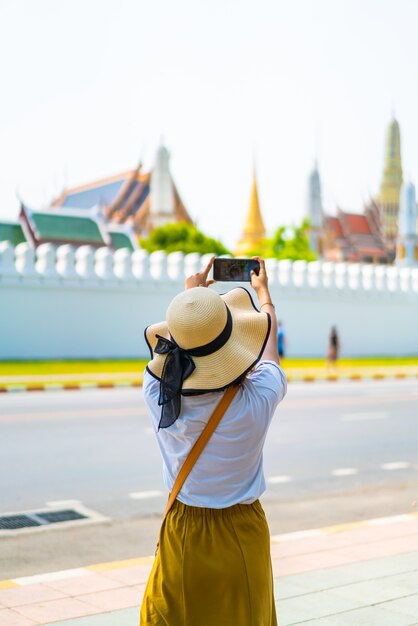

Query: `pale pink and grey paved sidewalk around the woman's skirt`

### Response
(0, 514, 418, 626)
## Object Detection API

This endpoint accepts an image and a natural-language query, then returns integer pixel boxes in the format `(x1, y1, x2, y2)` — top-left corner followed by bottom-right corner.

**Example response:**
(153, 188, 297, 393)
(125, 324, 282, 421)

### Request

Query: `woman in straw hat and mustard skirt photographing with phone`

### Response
(140, 257, 286, 626)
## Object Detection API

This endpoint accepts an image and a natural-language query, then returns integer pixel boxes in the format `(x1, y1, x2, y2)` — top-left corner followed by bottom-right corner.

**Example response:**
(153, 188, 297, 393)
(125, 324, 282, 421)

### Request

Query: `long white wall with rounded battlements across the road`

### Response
(0, 242, 418, 360)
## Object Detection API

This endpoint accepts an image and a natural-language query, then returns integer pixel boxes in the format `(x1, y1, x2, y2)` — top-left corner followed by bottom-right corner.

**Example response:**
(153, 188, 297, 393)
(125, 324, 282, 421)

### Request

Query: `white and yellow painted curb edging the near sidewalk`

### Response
(0, 513, 418, 589)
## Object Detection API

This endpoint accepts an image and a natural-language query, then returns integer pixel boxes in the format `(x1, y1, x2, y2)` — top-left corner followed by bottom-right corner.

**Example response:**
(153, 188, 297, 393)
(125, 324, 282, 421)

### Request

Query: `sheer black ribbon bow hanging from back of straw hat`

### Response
(154, 335, 196, 429)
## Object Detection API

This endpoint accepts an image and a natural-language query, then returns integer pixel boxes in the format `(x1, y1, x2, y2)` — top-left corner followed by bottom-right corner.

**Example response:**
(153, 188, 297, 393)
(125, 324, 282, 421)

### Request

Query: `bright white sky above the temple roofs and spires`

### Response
(0, 0, 418, 246)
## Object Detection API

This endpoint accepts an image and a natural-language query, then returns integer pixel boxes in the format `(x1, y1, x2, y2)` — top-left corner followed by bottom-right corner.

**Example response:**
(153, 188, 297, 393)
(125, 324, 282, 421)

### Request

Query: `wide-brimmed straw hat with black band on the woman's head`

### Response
(145, 287, 270, 395)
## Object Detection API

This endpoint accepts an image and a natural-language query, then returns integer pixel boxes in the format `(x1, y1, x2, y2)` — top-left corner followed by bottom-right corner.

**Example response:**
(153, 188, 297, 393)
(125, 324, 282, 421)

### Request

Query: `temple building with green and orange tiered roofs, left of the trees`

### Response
(0, 145, 192, 251)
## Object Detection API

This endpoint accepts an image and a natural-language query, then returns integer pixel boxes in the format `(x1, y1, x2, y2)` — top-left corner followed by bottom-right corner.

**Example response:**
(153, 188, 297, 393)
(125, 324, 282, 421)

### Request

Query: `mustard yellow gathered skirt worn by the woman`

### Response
(140, 500, 277, 626)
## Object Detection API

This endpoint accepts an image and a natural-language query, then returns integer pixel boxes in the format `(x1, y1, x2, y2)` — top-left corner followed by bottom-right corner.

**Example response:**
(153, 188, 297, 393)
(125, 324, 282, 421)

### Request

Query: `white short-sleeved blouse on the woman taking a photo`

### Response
(143, 361, 287, 509)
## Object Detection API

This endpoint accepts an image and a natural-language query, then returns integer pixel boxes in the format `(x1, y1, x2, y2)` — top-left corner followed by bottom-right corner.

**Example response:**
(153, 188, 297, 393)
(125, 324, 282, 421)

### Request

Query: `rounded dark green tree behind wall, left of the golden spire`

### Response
(140, 222, 229, 255)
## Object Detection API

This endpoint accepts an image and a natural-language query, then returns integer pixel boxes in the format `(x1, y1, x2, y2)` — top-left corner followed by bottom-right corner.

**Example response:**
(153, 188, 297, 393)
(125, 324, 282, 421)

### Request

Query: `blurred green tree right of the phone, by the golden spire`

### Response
(250, 219, 317, 261)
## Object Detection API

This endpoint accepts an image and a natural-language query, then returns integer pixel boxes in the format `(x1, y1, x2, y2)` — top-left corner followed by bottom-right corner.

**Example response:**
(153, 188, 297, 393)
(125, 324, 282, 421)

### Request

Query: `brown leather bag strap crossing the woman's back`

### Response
(164, 385, 239, 519)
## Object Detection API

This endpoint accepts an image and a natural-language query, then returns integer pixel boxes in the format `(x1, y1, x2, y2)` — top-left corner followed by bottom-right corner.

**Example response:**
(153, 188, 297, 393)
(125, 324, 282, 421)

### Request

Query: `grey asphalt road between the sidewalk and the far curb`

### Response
(0, 380, 418, 578)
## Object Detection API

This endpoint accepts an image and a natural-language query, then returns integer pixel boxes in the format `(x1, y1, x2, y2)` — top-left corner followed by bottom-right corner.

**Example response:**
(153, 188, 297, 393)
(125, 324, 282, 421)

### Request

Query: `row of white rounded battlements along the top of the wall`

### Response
(0, 242, 418, 295)
